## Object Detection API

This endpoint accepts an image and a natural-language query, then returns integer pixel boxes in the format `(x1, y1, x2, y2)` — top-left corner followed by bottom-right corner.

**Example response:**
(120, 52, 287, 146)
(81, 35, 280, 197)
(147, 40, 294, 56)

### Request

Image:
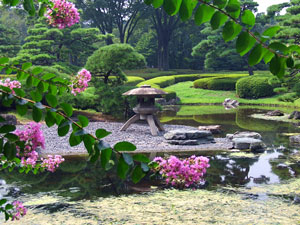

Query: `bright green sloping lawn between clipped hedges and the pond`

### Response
(164, 81, 300, 107)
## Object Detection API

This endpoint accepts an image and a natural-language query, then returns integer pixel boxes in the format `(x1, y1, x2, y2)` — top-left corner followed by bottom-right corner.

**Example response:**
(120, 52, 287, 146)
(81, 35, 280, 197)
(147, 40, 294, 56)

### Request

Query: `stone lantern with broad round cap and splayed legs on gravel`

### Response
(121, 85, 167, 136)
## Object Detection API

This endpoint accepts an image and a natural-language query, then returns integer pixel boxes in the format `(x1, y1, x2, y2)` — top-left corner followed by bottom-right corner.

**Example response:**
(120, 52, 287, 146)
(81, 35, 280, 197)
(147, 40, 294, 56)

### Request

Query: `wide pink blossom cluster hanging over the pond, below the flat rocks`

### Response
(153, 155, 210, 188)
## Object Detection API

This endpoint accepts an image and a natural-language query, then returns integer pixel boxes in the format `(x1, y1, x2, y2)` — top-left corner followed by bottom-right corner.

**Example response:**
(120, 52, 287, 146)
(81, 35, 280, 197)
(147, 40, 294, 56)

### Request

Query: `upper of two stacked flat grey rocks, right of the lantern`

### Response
(164, 129, 212, 140)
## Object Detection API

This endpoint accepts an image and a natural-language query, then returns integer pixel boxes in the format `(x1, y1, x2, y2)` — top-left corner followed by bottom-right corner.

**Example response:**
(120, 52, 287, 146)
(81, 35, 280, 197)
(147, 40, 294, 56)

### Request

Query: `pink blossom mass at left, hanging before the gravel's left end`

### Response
(14, 122, 64, 172)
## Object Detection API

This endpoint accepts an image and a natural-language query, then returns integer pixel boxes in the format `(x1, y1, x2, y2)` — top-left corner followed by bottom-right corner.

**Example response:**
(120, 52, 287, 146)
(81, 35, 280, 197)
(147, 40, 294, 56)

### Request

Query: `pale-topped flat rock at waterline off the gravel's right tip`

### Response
(232, 138, 265, 151)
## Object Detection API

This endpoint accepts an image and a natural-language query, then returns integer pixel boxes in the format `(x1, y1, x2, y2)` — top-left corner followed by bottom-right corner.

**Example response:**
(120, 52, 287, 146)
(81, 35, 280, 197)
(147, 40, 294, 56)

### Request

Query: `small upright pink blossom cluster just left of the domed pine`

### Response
(71, 69, 92, 96)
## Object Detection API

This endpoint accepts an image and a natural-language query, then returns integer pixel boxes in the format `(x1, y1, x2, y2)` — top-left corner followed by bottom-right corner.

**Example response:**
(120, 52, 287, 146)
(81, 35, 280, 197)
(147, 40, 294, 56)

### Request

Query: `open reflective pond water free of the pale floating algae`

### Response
(0, 106, 300, 224)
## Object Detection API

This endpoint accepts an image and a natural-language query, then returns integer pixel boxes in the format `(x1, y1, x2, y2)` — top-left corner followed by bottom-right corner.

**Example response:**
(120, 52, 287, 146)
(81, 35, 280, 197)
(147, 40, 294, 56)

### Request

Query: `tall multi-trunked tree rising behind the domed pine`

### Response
(76, 0, 146, 44)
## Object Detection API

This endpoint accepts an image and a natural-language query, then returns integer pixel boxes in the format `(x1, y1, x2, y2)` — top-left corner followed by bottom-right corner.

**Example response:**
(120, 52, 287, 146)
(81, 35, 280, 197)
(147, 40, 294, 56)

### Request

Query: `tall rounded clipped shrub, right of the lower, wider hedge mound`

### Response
(236, 75, 274, 98)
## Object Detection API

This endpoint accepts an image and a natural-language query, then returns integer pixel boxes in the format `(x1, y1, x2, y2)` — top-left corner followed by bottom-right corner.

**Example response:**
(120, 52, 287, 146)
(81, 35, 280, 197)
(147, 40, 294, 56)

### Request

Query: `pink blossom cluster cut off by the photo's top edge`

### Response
(45, 0, 80, 29)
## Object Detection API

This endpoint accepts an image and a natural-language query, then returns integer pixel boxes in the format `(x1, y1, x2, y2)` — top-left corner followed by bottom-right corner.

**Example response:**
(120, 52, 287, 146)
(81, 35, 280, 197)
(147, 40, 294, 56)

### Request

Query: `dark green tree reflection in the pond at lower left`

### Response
(0, 160, 125, 200)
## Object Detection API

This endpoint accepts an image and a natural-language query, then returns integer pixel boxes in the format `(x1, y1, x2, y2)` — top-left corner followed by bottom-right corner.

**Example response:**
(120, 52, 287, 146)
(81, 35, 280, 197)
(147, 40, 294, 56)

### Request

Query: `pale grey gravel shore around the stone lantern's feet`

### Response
(17, 122, 232, 155)
